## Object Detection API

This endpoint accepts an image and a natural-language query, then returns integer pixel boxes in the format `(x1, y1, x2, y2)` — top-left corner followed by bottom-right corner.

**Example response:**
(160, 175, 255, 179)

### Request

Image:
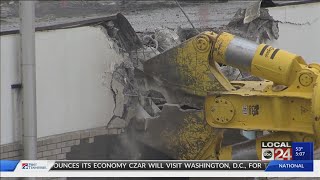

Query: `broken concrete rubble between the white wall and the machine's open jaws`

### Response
(108, 25, 214, 148)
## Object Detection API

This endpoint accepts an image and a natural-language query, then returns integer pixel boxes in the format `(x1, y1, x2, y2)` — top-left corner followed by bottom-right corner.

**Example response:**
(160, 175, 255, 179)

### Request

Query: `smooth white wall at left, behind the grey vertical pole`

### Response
(0, 27, 123, 144)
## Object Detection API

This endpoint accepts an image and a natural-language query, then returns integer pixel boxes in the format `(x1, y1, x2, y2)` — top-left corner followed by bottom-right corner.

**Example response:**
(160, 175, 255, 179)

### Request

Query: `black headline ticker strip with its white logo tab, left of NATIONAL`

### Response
(0, 160, 267, 172)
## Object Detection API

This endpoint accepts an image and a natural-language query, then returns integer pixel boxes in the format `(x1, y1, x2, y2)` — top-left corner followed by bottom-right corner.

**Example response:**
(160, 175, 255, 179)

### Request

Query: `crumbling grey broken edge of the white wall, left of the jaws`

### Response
(110, 44, 159, 130)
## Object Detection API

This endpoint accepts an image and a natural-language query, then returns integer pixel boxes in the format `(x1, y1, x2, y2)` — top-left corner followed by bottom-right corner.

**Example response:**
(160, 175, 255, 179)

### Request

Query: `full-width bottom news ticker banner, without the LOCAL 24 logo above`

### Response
(0, 160, 320, 177)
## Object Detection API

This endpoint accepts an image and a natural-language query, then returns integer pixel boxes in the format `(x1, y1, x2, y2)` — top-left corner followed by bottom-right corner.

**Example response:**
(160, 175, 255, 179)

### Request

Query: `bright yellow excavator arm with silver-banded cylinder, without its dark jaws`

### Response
(200, 32, 320, 159)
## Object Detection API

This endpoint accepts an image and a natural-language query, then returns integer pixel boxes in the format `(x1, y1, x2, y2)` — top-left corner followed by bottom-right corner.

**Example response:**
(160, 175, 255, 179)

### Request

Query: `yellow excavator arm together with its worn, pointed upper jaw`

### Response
(144, 32, 320, 159)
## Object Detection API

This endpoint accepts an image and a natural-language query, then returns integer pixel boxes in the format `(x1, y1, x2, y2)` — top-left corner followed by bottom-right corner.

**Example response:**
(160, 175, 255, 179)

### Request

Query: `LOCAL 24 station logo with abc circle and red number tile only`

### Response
(261, 141, 292, 161)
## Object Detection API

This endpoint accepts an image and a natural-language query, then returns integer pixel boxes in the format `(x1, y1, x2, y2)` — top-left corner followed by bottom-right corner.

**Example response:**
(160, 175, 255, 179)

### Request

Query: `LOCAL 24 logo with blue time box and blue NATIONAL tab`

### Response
(261, 141, 314, 171)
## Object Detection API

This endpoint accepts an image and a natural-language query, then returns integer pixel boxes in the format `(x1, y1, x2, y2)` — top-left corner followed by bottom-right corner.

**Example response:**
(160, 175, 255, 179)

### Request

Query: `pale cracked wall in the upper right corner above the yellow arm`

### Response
(269, 3, 320, 63)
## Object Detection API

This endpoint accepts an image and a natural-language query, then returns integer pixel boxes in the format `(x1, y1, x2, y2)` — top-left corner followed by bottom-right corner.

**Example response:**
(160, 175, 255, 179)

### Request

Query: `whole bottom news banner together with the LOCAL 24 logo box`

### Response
(0, 141, 320, 177)
